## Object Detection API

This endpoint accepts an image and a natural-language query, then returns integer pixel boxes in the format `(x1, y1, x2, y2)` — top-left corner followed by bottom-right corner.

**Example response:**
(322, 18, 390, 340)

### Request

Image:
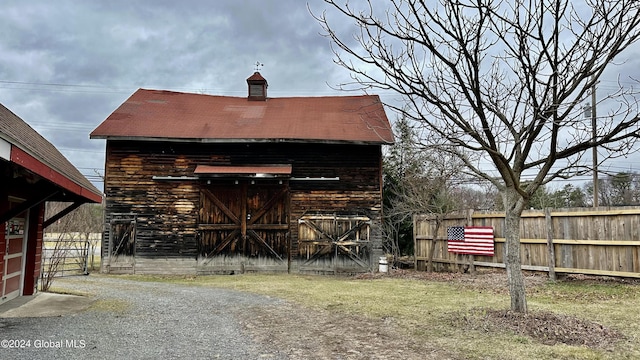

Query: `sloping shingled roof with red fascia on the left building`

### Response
(0, 104, 102, 202)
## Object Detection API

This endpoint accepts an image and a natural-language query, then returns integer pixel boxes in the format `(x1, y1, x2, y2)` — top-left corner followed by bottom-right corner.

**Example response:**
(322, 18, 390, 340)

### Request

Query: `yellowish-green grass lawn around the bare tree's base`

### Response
(106, 272, 640, 359)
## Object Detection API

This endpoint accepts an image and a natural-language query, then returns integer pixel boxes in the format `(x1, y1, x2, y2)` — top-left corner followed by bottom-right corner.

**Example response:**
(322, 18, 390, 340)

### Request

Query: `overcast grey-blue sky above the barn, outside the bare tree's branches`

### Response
(0, 0, 640, 193)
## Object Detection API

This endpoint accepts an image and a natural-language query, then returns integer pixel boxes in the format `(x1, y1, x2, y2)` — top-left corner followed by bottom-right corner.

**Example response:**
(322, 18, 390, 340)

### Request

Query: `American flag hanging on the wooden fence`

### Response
(447, 226, 494, 256)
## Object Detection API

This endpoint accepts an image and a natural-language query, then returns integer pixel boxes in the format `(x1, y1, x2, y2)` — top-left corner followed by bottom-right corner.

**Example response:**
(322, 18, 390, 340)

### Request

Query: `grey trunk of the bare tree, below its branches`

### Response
(504, 189, 527, 313)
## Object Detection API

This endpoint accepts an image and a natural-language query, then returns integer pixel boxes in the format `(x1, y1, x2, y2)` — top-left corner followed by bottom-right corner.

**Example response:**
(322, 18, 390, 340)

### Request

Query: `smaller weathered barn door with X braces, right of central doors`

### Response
(298, 214, 371, 272)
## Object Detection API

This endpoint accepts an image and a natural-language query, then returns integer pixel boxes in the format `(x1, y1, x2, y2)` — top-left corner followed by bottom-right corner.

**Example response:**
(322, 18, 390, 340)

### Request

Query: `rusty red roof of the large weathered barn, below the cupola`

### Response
(91, 89, 393, 144)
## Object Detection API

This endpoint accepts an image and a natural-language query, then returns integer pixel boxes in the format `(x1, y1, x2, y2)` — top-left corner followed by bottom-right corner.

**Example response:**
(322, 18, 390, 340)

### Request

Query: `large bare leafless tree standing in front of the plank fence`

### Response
(314, 0, 640, 312)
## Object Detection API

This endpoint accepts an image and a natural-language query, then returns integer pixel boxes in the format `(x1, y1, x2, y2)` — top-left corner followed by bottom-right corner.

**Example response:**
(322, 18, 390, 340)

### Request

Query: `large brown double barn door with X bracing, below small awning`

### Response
(198, 180, 289, 263)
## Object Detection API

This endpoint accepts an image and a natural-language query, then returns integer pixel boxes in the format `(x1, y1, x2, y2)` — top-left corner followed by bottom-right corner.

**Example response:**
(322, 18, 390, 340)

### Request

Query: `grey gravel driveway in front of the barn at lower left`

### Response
(0, 276, 288, 359)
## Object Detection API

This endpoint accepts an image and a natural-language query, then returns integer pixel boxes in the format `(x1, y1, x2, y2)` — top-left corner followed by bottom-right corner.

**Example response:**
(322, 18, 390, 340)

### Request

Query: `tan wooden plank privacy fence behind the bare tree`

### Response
(413, 207, 640, 278)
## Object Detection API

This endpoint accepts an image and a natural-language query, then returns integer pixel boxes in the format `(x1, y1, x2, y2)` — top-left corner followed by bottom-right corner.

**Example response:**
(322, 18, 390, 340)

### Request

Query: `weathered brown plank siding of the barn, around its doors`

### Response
(103, 141, 381, 270)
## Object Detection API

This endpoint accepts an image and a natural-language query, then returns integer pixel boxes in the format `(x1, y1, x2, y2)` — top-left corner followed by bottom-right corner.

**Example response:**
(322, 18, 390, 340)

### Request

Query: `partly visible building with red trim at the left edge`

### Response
(0, 105, 102, 303)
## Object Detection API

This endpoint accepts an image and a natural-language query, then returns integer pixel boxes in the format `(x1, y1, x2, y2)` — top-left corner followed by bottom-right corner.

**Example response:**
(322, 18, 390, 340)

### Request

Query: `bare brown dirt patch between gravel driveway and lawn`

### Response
(238, 303, 456, 359)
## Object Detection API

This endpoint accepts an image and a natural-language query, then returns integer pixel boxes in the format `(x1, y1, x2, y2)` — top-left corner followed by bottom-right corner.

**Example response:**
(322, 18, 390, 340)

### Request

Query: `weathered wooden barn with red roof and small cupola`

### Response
(90, 72, 393, 274)
